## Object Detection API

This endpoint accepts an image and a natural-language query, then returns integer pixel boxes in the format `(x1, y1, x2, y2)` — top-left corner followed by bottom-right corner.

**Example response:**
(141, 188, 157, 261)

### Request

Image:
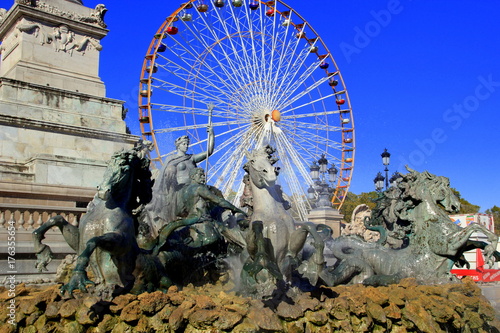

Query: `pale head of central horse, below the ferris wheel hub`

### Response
(243, 147, 279, 188)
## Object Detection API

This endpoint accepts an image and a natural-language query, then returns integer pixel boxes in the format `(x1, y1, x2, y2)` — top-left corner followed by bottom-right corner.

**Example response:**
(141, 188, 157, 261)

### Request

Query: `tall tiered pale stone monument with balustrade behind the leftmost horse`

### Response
(0, 0, 137, 281)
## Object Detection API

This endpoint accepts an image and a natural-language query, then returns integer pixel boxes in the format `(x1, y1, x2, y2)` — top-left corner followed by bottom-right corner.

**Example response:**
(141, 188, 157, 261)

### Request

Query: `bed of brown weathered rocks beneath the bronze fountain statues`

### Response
(0, 279, 500, 333)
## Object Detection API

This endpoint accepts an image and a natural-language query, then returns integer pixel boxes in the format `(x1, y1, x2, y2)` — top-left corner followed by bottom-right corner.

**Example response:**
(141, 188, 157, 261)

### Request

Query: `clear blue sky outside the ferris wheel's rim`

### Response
(84, 0, 500, 211)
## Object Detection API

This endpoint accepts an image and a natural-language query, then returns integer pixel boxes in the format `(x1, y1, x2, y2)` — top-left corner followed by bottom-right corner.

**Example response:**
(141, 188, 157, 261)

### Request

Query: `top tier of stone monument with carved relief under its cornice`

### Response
(0, 0, 108, 97)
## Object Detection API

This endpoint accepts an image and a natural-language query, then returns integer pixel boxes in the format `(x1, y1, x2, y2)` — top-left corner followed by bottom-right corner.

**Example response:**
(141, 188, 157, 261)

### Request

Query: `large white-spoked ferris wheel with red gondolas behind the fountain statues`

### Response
(139, 0, 355, 220)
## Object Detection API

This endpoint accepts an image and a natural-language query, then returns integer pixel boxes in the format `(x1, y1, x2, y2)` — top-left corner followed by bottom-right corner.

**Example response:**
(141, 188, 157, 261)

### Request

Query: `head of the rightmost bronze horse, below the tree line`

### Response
(404, 169, 460, 213)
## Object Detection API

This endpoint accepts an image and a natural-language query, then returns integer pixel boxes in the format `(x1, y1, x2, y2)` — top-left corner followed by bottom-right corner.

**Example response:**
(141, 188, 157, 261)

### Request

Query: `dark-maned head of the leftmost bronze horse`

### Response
(97, 151, 152, 209)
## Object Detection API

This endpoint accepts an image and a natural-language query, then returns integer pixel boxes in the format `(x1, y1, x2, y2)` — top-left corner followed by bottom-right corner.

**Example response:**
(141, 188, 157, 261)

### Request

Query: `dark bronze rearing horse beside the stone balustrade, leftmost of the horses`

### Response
(33, 147, 152, 294)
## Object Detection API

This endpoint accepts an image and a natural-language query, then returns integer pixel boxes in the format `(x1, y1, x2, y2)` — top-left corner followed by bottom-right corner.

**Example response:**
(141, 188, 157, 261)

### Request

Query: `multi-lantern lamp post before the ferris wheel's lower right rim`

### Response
(307, 154, 338, 208)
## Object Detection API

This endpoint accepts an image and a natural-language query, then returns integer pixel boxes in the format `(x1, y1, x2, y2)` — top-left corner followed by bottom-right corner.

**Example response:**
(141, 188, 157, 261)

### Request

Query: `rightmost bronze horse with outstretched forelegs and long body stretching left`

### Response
(325, 169, 500, 285)
